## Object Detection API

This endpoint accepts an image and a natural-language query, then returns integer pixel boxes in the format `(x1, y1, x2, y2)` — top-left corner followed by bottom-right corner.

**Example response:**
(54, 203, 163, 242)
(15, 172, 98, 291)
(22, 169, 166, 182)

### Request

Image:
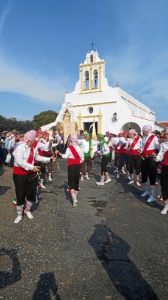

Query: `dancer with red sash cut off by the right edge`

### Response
(153, 128, 168, 215)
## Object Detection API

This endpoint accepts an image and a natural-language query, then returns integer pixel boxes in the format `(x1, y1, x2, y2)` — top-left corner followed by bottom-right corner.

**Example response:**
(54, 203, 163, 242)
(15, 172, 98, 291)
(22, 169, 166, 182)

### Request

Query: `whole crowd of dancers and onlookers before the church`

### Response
(0, 125, 168, 223)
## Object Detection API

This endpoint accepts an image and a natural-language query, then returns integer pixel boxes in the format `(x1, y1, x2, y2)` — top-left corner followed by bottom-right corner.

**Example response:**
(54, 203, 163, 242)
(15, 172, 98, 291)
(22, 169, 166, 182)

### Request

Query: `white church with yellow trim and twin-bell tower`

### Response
(42, 50, 164, 134)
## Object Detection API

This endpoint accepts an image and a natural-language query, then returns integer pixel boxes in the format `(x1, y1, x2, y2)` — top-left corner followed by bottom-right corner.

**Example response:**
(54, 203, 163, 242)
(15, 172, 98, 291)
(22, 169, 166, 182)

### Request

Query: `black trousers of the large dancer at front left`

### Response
(13, 173, 38, 205)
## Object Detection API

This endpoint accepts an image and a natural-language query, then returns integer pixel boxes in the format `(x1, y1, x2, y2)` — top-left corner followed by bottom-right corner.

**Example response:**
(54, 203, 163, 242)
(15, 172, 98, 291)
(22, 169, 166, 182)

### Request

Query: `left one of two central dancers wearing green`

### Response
(78, 132, 97, 180)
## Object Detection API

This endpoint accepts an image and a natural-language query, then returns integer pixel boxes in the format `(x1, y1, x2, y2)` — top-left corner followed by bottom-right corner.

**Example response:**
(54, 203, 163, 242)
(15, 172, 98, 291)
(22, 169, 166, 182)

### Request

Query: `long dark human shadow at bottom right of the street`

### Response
(89, 224, 158, 300)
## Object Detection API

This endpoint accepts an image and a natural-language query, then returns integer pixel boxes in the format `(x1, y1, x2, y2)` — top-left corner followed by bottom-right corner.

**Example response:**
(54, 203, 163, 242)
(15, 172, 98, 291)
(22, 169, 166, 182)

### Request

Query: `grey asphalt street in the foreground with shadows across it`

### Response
(0, 159, 168, 300)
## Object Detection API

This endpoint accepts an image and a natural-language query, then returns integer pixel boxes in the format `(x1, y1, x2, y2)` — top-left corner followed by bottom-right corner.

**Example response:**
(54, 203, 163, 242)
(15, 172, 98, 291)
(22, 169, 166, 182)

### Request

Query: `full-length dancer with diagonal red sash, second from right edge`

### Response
(140, 125, 159, 203)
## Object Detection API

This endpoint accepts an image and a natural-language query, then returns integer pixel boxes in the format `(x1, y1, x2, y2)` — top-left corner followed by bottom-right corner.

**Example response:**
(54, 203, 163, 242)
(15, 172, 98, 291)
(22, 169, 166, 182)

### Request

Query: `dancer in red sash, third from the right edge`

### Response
(128, 129, 142, 186)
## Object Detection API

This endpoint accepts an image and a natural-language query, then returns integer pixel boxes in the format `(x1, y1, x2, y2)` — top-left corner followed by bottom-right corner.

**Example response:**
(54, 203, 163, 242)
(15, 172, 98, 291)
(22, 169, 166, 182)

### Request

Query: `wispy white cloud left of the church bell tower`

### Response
(0, 58, 65, 104)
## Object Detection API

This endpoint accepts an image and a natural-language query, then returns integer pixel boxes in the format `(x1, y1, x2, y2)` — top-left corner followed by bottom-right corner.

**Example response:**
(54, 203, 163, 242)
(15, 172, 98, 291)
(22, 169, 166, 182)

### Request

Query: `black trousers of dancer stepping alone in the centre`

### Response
(68, 165, 81, 191)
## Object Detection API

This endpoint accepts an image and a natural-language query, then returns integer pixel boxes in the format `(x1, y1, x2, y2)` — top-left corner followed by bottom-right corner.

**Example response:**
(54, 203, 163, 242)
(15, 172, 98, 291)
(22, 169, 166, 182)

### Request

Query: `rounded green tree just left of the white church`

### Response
(33, 110, 58, 129)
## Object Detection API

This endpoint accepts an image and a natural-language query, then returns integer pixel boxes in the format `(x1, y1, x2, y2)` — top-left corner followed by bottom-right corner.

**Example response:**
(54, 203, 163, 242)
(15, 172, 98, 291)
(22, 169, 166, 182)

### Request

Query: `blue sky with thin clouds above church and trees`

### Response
(0, 0, 168, 121)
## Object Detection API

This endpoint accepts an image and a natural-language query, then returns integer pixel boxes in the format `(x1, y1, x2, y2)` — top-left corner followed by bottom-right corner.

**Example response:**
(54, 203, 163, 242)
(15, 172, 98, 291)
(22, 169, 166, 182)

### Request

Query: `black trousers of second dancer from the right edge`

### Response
(141, 156, 157, 185)
